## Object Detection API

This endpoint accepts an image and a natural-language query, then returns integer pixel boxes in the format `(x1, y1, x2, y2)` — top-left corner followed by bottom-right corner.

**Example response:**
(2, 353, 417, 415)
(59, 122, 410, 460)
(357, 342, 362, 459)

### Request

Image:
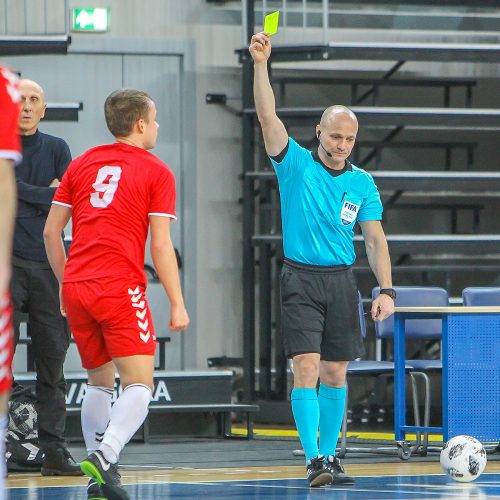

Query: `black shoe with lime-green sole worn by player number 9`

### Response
(80, 451, 130, 500)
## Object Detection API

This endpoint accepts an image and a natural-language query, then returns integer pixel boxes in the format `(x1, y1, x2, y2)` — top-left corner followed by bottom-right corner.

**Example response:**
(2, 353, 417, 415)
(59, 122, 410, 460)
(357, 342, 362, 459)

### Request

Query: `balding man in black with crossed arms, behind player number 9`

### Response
(11, 80, 81, 476)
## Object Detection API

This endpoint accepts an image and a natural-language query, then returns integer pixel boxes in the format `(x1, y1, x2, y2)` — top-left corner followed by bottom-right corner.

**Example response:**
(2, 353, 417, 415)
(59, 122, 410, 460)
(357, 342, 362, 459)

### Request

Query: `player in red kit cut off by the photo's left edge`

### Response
(0, 66, 21, 500)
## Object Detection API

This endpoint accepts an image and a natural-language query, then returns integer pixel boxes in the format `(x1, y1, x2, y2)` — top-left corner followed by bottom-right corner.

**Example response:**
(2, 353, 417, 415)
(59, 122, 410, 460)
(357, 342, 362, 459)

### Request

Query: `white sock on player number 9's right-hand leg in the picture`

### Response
(99, 384, 151, 464)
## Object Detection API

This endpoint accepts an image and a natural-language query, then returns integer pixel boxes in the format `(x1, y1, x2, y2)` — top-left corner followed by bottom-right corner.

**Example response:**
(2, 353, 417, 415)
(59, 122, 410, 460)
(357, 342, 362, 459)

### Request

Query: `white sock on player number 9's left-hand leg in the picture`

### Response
(81, 385, 113, 455)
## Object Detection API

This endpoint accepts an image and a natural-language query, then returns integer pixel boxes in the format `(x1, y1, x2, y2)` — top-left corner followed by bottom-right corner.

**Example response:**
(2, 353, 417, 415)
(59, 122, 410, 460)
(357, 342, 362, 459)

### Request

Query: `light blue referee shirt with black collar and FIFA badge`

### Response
(271, 138, 383, 266)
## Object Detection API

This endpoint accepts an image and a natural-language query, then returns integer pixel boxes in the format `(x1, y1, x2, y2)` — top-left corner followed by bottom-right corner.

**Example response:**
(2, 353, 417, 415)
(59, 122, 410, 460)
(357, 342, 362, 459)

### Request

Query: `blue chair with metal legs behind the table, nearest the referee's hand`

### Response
(372, 286, 449, 454)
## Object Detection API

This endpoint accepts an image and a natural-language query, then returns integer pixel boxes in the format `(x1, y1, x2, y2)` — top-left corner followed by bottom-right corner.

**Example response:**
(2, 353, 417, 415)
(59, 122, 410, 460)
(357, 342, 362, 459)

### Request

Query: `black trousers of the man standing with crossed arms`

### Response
(11, 258, 70, 448)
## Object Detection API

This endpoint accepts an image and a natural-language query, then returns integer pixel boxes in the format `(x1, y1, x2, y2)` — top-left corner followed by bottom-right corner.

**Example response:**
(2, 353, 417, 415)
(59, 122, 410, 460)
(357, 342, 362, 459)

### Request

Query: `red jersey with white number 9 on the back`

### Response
(52, 142, 176, 283)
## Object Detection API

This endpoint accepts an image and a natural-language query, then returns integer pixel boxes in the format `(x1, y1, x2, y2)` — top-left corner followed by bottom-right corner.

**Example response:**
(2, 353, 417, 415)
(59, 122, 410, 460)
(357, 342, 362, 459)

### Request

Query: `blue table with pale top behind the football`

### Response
(394, 306, 500, 442)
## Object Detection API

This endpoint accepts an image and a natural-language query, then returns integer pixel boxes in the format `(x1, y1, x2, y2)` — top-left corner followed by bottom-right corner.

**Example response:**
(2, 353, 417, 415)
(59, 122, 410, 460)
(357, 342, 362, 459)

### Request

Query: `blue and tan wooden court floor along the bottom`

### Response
(7, 460, 500, 500)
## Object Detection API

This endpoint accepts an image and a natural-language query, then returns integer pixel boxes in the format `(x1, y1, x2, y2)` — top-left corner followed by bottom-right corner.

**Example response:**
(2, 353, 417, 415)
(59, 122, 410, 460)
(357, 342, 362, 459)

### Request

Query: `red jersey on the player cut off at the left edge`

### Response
(0, 66, 21, 163)
